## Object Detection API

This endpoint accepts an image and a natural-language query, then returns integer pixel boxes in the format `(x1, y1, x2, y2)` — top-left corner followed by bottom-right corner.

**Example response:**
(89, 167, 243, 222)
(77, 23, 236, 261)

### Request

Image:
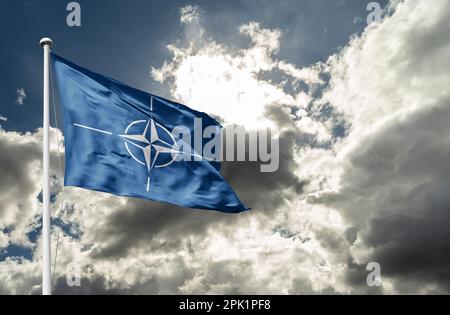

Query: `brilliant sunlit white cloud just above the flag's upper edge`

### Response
(152, 22, 322, 128)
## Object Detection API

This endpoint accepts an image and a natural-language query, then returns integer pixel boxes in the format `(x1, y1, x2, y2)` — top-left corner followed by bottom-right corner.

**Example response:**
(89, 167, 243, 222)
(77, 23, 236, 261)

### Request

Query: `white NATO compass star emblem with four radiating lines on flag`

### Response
(73, 97, 189, 191)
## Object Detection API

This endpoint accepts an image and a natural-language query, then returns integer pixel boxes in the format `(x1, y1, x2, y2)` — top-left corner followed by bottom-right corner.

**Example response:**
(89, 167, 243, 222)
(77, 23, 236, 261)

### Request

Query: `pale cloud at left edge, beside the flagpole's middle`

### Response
(0, 129, 62, 247)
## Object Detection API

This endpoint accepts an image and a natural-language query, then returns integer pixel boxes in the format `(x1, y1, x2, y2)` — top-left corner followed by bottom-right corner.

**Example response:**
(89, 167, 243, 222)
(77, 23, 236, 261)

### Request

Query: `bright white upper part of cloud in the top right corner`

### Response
(324, 0, 450, 138)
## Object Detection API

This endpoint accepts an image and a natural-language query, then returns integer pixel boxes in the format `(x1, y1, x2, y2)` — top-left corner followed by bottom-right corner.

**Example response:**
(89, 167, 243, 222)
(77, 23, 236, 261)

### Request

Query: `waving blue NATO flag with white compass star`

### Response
(52, 54, 248, 212)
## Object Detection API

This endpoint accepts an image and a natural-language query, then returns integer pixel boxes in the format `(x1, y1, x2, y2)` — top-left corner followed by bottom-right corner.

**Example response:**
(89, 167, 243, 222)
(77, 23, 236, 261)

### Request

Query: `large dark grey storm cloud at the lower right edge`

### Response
(322, 98, 450, 291)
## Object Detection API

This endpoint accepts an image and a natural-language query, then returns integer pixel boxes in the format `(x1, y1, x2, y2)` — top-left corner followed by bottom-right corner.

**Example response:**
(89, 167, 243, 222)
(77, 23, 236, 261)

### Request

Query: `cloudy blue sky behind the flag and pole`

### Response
(0, 0, 450, 294)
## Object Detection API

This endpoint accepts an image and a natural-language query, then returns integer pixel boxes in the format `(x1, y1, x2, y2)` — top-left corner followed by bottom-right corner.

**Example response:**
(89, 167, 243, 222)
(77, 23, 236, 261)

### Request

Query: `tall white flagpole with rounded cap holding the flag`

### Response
(39, 37, 53, 295)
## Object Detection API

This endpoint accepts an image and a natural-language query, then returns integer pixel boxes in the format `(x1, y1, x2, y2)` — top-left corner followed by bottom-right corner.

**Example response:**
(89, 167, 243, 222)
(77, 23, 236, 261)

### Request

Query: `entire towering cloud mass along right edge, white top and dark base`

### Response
(309, 1, 450, 293)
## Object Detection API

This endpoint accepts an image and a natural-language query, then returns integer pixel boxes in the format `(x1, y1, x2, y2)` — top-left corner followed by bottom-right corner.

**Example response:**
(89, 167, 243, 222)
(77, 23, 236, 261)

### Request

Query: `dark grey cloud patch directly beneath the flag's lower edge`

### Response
(88, 199, 220, 258)
